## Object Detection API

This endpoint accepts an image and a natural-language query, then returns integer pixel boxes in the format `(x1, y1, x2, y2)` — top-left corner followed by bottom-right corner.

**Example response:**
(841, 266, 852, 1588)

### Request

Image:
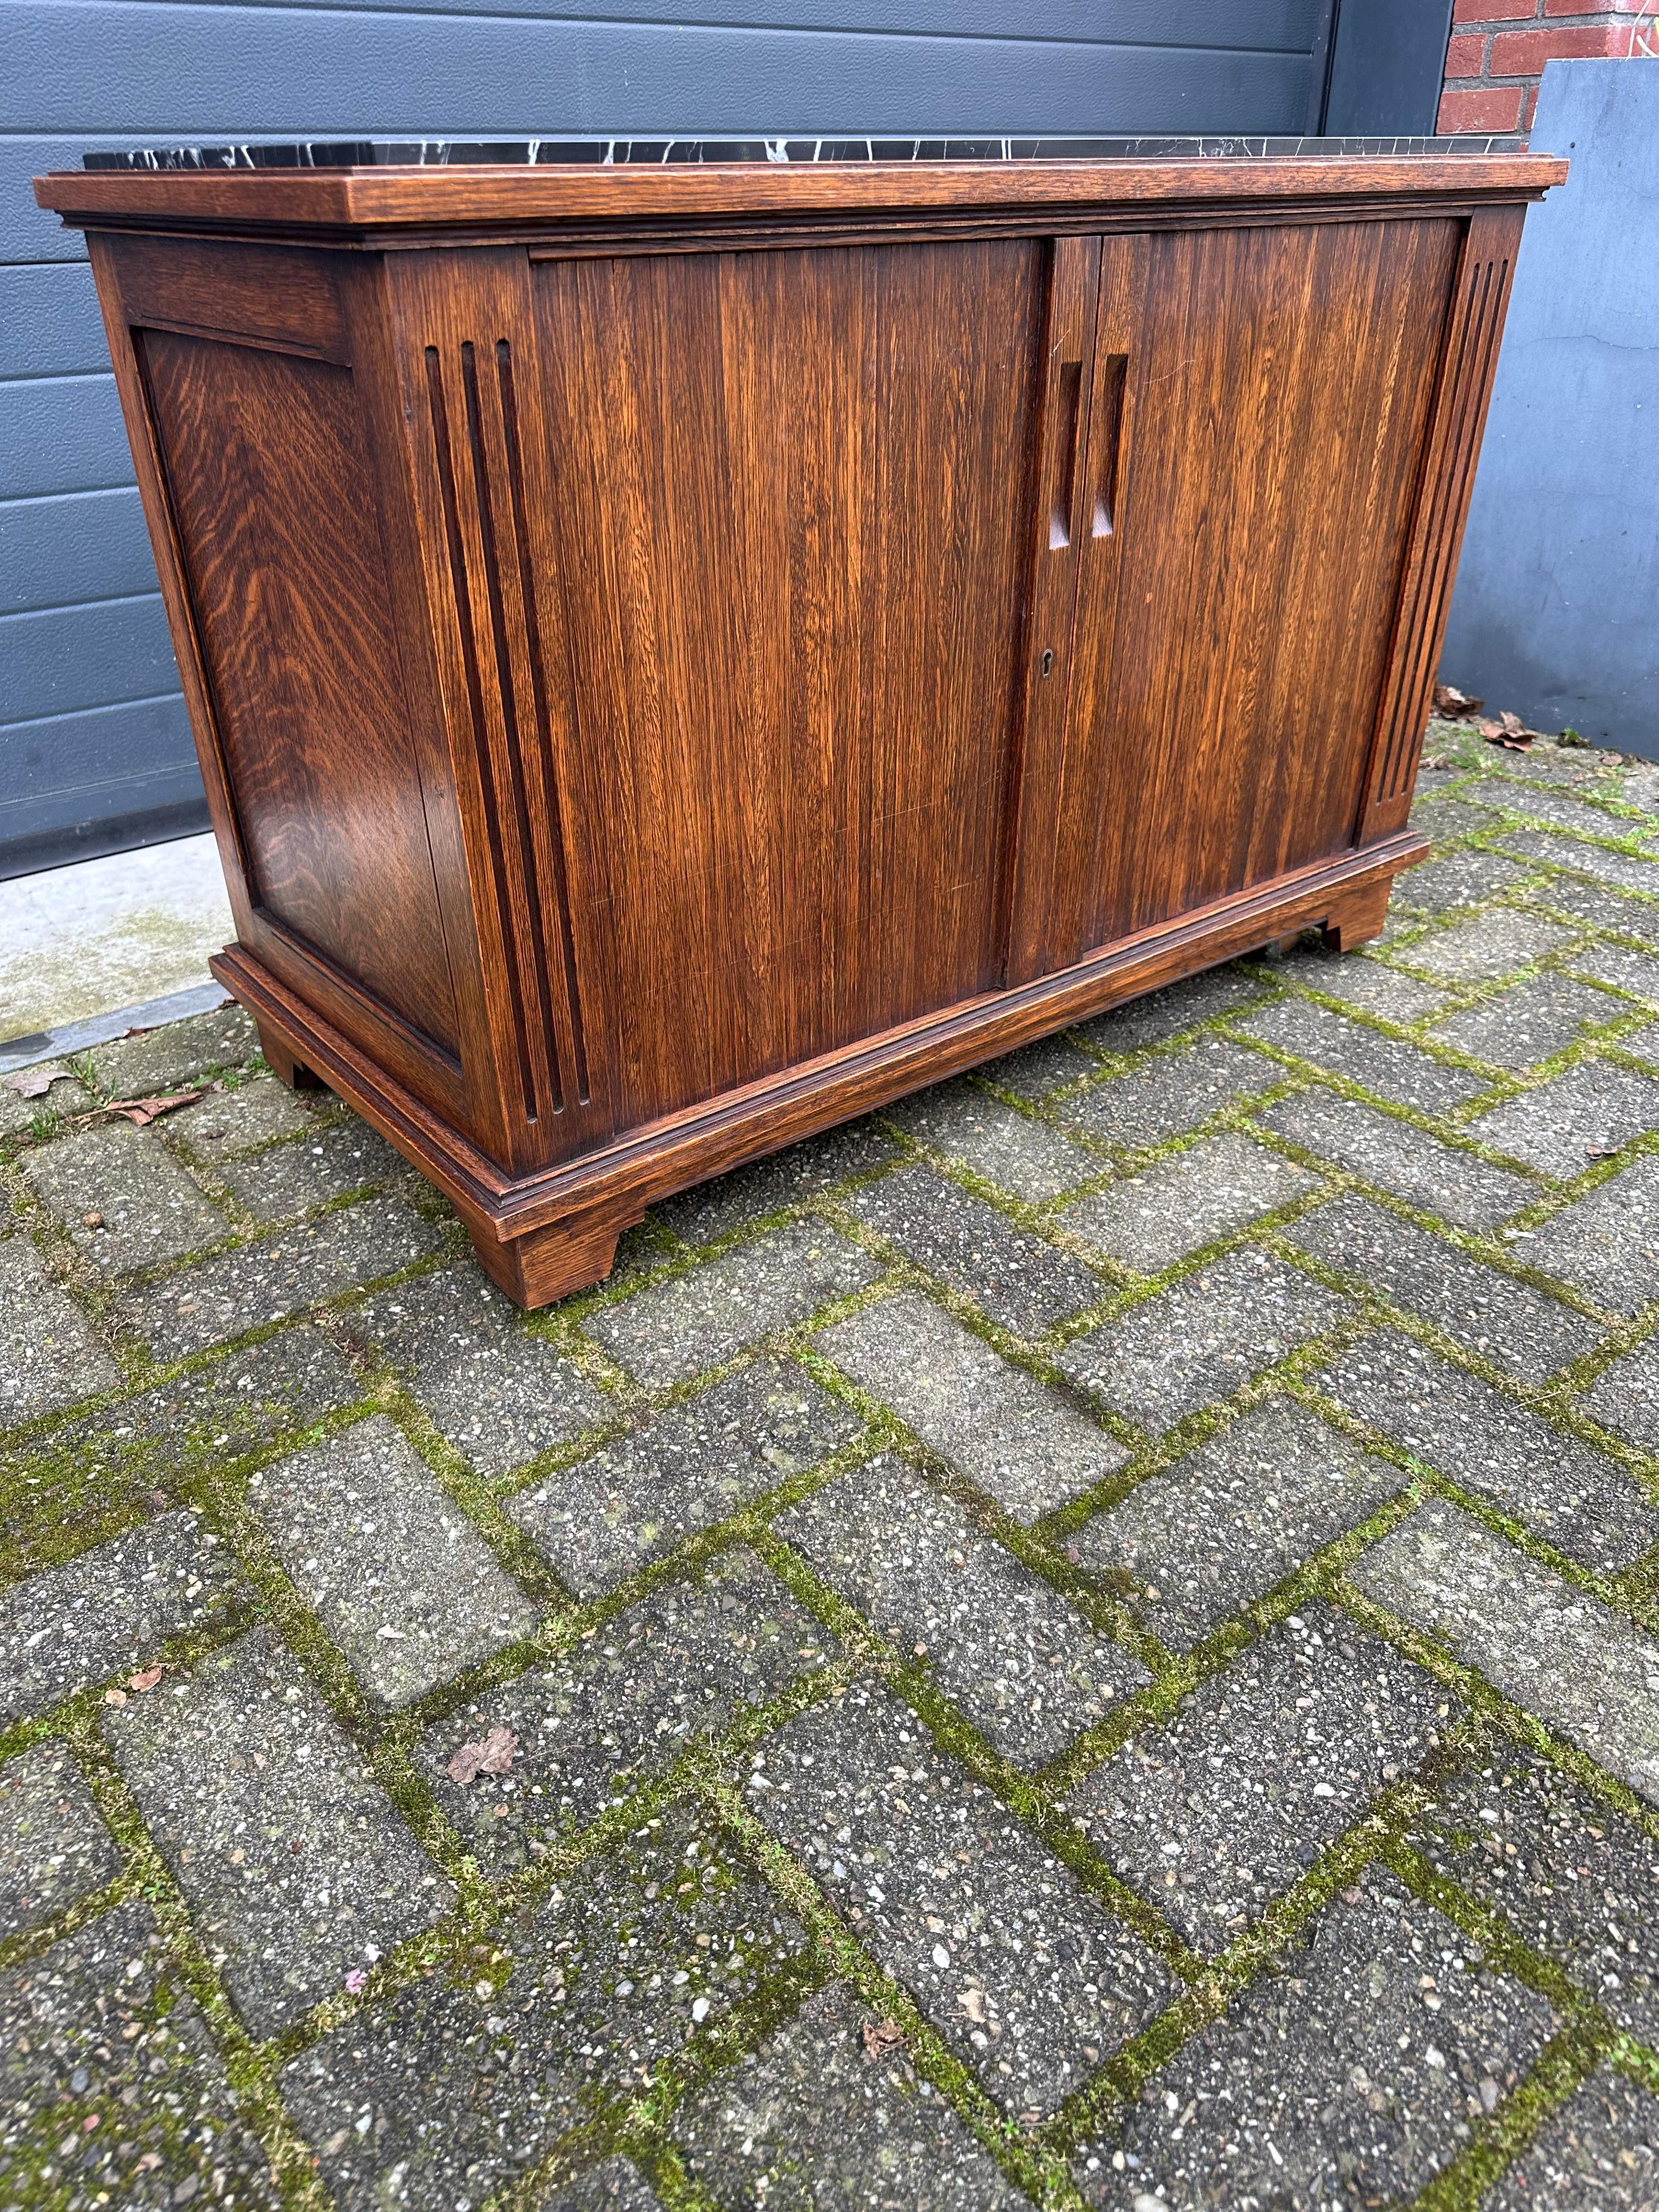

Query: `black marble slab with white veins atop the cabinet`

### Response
(82, 137, 1526, 168)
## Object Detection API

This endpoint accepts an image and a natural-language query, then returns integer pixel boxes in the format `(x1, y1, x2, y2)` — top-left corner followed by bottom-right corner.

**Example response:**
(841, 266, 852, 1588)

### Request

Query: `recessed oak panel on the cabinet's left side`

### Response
(135, 330, 456, 1055)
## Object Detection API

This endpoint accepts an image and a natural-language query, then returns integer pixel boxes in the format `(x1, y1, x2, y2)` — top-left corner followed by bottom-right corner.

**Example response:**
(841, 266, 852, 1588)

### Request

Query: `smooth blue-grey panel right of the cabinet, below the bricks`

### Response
(1442, 60, 1659, 759)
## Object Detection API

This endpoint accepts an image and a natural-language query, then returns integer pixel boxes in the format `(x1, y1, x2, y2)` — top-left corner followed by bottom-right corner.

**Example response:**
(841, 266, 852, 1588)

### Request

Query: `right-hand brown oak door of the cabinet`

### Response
(1048, 219, 1460, 964)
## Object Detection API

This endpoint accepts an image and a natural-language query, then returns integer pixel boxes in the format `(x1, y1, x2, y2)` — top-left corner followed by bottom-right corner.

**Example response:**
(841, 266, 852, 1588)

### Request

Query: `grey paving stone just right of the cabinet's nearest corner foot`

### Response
(584, 1221, 887, 1389)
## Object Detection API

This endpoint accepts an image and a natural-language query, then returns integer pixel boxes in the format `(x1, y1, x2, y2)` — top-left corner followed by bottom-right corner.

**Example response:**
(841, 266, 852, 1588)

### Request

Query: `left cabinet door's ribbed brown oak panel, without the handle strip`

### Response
(538, 241, 1044, 1124)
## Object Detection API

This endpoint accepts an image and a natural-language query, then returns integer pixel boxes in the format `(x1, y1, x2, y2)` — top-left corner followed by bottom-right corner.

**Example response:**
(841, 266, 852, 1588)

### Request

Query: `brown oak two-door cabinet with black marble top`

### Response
(36, 142, 1566, 1305)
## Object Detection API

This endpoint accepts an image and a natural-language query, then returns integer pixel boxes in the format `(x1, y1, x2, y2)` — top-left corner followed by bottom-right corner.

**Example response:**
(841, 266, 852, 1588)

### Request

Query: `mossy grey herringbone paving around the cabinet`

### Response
(0, 728, 1659, 2212)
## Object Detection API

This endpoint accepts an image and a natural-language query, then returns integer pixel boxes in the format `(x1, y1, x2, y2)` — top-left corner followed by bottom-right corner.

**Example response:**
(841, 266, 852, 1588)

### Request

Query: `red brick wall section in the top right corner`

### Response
(1436, 0, 1659, 135)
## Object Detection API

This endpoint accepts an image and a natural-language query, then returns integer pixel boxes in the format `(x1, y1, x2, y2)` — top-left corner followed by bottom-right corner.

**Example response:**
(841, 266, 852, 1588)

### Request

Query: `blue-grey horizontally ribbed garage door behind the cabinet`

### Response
(0, 0, 1323, 876)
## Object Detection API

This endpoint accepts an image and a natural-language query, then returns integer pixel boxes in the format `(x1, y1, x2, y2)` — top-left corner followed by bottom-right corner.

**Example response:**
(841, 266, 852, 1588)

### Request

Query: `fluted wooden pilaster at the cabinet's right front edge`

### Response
(1356, 208, 1524, 845)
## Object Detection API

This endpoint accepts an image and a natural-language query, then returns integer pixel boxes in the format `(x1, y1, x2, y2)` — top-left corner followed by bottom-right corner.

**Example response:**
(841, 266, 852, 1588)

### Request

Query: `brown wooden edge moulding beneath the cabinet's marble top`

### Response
(36, 153, 1566, 232)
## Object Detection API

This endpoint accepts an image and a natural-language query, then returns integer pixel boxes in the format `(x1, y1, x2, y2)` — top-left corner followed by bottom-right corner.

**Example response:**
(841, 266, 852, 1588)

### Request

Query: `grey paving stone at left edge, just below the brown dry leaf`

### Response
(22, 1121, 230, 1274)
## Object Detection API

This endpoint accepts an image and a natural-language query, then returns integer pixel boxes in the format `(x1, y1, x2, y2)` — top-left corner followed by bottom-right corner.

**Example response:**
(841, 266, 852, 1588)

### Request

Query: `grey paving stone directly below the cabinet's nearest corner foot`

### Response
(347, 1263, 615, 1477)
